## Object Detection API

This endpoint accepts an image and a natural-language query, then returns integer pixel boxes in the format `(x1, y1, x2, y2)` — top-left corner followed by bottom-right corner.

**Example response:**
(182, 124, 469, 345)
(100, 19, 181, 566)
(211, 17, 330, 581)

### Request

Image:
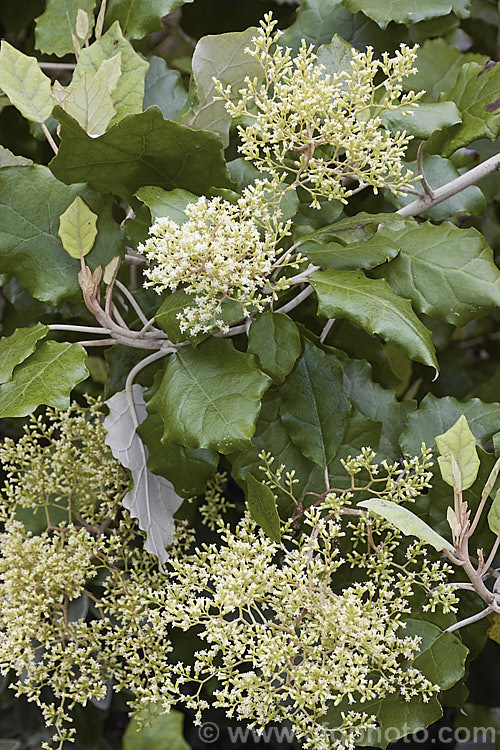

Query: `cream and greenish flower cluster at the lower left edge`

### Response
(0, 403, 171, 750)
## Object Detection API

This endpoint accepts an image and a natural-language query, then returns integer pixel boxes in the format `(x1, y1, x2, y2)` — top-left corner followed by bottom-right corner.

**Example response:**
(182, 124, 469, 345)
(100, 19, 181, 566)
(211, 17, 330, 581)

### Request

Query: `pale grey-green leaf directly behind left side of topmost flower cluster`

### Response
(182, 27, 263, 147)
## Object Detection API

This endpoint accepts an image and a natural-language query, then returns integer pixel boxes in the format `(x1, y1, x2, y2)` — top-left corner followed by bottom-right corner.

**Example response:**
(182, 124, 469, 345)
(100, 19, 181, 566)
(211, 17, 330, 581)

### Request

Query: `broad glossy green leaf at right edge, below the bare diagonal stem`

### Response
(379, 222, 500, 325)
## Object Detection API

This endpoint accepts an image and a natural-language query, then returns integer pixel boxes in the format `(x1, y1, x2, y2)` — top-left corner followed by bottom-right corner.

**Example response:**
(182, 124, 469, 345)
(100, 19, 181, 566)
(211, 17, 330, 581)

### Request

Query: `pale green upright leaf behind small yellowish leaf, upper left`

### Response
(68, 23, 148, 125)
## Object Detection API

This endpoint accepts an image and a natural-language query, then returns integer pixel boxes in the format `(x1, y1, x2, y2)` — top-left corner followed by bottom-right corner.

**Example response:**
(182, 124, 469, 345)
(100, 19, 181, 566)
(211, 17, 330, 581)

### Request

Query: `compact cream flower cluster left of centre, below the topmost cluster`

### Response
(138, 182, 290, 335)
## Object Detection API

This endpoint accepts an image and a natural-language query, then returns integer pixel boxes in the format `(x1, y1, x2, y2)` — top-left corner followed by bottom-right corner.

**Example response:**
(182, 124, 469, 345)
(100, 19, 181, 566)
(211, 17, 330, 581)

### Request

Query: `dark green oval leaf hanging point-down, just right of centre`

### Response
(280, 341, 350, 467)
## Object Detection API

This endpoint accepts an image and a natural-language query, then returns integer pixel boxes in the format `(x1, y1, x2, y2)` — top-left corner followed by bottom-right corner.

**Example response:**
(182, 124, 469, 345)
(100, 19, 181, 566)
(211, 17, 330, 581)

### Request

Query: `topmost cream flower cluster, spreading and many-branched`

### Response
(214, 13, 423, 207)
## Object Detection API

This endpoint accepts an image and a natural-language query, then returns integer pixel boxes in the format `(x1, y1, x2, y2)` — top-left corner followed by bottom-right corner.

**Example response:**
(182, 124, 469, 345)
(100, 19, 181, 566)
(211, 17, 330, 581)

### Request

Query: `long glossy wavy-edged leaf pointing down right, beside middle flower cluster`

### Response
(309, 271, 438, 371)
